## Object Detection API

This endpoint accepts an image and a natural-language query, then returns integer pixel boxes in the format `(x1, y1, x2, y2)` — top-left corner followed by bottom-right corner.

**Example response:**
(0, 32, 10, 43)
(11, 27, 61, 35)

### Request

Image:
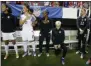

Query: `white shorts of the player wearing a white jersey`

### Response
(21, 30, 34, 41)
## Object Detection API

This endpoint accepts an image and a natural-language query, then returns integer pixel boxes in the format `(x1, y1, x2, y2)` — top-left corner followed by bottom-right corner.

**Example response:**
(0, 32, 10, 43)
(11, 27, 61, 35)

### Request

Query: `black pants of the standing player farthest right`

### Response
(77, 34, 86, 54)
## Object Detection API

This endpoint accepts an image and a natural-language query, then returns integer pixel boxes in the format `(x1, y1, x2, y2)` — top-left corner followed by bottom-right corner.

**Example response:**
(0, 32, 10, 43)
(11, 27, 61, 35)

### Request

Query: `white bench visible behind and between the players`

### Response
(1, 30, 78, 51)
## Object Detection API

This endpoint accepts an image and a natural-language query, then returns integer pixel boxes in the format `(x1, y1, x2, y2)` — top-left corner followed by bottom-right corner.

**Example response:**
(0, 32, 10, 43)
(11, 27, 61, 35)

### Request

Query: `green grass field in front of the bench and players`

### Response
(1, 47, 91, 66)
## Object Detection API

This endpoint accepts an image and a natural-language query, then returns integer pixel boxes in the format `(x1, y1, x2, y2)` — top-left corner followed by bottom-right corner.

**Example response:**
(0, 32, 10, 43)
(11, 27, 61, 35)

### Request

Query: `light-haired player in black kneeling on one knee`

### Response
(52, 21, 67, 65)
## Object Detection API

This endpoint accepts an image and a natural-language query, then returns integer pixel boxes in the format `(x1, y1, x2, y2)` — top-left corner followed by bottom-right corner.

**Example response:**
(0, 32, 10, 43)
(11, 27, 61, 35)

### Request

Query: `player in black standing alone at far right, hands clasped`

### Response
(76, 8, 89, 58)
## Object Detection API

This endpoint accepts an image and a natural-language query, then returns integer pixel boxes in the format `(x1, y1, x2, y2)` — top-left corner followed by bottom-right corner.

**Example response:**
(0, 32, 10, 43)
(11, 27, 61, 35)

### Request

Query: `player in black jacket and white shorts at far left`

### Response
(1, 3, 19, 59)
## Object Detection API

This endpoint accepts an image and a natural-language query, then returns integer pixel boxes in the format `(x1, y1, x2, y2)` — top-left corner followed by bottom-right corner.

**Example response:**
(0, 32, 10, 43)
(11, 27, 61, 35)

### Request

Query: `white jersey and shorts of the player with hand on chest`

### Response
(21, 14, 36, 41)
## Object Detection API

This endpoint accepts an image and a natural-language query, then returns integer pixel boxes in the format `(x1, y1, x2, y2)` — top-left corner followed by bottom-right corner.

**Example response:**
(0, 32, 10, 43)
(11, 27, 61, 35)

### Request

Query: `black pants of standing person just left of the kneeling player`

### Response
(39, 33, 50, 53)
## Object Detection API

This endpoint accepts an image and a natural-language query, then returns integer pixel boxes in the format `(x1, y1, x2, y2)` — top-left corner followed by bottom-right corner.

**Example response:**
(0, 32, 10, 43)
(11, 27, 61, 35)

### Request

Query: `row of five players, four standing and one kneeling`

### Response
(1, 3, 89, 65)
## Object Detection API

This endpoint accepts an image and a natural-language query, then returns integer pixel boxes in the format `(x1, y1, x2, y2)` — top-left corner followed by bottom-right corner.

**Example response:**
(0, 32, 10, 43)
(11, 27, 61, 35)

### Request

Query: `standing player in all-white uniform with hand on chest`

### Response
(20, 4, 36, 57)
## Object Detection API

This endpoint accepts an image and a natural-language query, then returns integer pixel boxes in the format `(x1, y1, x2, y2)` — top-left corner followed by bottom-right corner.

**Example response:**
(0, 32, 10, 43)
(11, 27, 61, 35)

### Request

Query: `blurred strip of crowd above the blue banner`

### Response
(1, 1, 91, 8)
